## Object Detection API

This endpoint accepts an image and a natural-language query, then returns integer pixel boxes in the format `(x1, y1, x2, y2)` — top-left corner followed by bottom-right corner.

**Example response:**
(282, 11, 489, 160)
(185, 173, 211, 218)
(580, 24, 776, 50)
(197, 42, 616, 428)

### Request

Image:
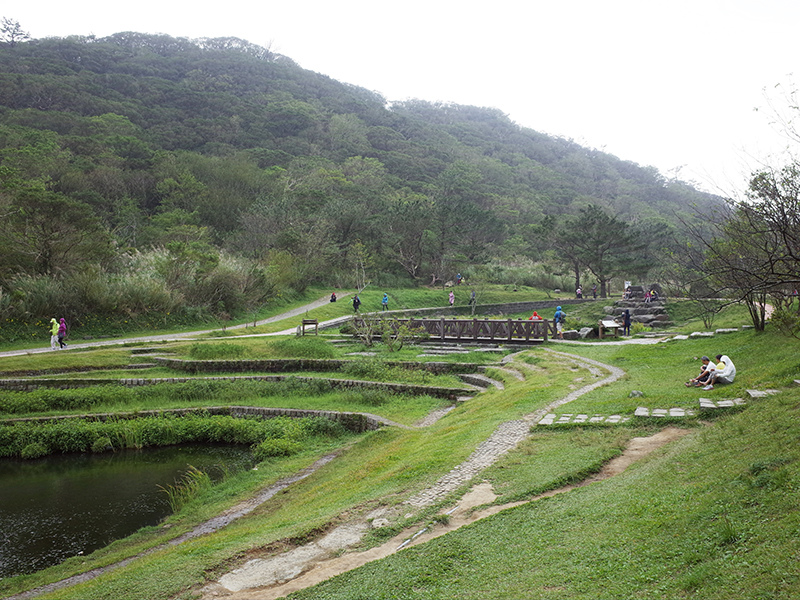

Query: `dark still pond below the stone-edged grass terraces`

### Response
(0, 444, 254, 577)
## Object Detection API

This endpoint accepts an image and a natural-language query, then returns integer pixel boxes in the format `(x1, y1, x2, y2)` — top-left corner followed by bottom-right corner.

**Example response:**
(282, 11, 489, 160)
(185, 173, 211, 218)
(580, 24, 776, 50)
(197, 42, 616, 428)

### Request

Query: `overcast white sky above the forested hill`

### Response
(6, 0, 800, 194)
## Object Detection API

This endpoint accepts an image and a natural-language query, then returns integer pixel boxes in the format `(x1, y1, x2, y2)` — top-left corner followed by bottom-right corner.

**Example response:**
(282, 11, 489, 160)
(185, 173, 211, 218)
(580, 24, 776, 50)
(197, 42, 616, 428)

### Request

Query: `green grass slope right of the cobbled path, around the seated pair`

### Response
(291, 332, 800, 600)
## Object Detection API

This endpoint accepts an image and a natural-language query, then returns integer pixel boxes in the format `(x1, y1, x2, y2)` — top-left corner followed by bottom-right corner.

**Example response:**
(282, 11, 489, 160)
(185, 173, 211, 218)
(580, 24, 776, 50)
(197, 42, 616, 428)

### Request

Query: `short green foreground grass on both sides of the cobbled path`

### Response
(0, 291, 800, 600)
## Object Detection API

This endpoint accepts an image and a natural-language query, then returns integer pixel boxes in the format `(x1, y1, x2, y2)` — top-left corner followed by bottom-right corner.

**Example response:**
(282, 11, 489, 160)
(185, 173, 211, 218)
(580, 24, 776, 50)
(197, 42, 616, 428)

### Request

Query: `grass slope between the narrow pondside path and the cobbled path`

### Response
(0, 344, 588, 598)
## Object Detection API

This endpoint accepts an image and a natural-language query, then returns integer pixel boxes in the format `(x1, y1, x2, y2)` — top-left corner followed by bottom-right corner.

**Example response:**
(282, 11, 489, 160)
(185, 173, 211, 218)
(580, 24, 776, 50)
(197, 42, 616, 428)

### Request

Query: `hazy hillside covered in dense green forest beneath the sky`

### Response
(0, 32, 720, 338)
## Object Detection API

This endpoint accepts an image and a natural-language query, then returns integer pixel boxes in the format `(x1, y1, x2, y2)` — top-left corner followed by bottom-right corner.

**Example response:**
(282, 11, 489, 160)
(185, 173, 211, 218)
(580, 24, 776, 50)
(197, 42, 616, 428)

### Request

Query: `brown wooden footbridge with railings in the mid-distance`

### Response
(355, 317, 555, 343)
